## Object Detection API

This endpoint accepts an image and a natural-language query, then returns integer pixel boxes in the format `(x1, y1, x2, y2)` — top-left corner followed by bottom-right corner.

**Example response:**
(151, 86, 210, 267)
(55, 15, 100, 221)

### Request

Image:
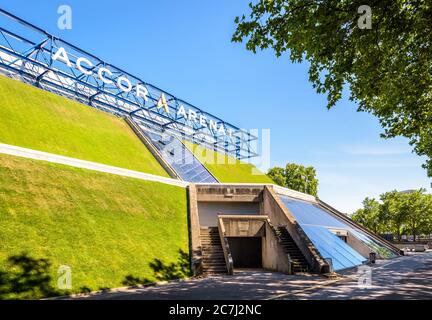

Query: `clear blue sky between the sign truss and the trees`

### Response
(0, 0, 431, 212)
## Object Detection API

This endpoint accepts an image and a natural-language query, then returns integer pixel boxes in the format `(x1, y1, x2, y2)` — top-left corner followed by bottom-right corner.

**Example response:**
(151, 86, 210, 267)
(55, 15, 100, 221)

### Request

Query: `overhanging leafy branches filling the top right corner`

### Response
(232, 0, 432, 176)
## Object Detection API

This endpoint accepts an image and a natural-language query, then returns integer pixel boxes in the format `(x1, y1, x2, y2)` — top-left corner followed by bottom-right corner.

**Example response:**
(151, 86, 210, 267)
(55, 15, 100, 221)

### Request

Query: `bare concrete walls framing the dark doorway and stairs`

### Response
(189, 185, 329, 275)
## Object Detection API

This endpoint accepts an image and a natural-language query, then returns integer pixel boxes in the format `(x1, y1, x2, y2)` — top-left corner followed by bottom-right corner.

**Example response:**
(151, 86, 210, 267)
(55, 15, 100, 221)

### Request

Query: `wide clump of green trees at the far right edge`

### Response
(352, 189, 432, 241)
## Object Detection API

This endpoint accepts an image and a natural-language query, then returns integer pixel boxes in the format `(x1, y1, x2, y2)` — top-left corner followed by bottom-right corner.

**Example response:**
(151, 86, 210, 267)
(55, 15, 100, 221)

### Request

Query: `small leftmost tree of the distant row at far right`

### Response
(351, 198, 385, 233)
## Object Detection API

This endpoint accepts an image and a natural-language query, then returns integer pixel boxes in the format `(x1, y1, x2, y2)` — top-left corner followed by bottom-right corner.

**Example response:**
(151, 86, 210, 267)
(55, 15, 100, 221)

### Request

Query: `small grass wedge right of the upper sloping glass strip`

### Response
(184, 141, 274, 183)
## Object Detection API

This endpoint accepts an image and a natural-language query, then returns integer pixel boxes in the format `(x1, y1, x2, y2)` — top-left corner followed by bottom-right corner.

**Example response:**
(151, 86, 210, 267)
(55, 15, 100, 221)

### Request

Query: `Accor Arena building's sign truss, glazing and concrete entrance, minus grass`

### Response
(0, 9, 400, 275)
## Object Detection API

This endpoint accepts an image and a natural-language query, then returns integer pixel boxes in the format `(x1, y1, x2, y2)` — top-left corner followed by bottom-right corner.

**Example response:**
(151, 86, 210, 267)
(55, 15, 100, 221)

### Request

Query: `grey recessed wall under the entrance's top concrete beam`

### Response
(198, 202, 260, 227)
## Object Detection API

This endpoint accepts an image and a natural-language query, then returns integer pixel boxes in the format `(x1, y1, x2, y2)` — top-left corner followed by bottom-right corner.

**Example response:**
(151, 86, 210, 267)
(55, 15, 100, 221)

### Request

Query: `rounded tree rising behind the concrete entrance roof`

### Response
(267, 163, 318, 197)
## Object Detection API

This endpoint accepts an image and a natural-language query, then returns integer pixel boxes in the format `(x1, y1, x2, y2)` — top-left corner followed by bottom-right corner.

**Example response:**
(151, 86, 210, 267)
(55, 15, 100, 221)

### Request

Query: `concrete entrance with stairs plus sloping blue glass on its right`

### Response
(189, 184, 399, 275)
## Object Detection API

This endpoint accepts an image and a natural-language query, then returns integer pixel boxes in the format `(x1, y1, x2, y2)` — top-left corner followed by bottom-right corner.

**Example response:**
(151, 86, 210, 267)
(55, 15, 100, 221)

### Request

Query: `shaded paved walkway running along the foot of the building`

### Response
(76, 252, 432, 300)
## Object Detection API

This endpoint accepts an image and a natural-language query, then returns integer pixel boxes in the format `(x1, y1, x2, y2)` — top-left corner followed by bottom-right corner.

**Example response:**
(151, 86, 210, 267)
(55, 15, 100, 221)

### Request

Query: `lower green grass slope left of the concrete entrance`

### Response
(0, 155, 188, 299)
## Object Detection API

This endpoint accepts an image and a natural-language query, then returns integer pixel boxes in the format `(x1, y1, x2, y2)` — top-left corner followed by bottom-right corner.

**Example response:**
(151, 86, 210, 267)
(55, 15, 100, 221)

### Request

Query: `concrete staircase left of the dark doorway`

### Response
(200, 227, 227, 275)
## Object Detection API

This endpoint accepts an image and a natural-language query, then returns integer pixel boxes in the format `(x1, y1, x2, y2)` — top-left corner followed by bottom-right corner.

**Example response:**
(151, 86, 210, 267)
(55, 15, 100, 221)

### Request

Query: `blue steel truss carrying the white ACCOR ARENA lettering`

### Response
(0, 9, 258, 159)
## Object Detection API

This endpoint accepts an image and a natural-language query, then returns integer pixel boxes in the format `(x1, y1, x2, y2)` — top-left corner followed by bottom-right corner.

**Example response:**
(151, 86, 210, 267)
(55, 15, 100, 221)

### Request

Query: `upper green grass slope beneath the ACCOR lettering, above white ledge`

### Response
(0, 76, 168, 177)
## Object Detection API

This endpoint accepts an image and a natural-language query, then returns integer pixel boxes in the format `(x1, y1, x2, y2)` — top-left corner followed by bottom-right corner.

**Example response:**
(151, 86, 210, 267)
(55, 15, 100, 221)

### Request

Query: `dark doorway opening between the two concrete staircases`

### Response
(228, 237, 262, 268)
